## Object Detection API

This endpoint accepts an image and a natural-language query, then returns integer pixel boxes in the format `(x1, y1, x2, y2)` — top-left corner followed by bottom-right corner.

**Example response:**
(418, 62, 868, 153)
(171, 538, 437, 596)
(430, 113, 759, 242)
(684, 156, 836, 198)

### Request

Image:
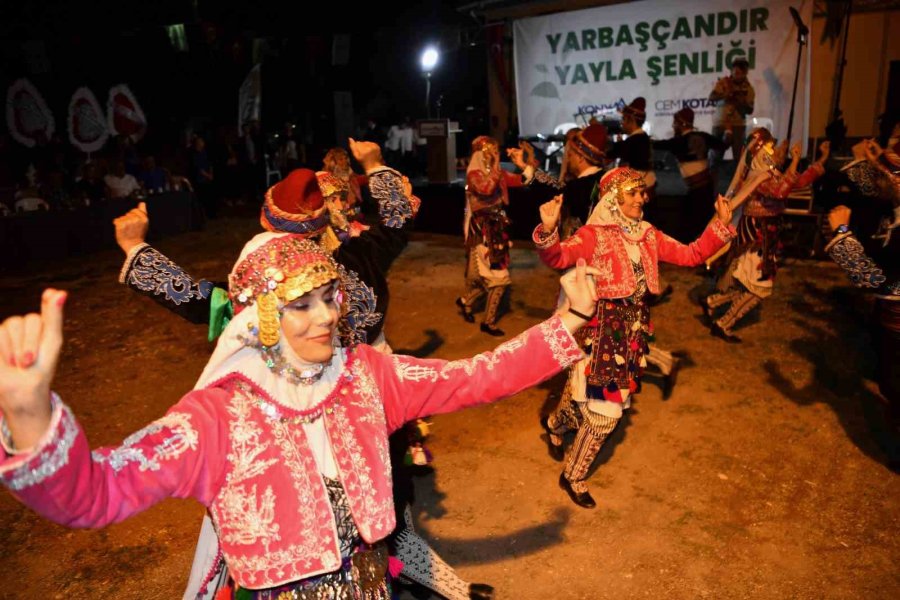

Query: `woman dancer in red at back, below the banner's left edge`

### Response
(456, 135, 522, 336)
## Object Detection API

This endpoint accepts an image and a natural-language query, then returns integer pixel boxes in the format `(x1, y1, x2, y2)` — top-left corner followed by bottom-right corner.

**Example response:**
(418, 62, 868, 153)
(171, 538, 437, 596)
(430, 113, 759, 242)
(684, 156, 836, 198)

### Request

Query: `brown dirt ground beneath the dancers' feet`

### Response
(0, 214, 900, 599)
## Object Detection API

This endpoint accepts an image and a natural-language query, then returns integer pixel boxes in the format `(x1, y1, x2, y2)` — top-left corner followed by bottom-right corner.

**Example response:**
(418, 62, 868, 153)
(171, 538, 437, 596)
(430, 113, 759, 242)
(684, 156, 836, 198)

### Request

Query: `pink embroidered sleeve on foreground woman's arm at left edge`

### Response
(0, 390, 228, 528)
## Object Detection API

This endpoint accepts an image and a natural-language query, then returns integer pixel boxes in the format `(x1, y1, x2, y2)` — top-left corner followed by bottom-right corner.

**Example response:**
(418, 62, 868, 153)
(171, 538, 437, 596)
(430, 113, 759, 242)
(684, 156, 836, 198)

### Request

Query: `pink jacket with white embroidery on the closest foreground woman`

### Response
(0, 317, 583, 589)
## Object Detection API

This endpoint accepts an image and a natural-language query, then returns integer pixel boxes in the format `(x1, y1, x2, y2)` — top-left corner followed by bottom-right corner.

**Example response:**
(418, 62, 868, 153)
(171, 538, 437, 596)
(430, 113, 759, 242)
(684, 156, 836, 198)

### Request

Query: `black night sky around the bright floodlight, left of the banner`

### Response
(0, 0, 487, 155)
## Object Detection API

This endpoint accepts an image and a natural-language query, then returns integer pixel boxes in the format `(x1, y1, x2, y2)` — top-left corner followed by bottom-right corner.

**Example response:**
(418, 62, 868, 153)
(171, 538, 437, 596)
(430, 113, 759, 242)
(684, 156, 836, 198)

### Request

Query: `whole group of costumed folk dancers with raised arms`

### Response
(0, 99, 900, 600)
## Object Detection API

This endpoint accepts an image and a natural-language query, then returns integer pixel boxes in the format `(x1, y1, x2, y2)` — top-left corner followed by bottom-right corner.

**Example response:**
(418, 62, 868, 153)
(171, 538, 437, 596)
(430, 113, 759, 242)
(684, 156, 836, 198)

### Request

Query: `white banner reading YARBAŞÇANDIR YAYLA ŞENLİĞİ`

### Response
(514, 0, 813, 140)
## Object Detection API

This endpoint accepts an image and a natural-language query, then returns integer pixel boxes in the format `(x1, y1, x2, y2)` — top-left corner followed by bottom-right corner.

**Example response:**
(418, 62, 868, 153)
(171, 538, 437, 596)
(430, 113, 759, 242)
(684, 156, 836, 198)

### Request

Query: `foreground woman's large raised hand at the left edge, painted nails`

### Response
(0, 289, 66, 449)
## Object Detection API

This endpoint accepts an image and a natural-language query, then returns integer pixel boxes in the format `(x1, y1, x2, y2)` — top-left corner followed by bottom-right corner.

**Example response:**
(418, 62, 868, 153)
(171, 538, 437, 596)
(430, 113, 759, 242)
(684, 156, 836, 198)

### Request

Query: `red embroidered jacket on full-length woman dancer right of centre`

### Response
(532, 219, 734, 298)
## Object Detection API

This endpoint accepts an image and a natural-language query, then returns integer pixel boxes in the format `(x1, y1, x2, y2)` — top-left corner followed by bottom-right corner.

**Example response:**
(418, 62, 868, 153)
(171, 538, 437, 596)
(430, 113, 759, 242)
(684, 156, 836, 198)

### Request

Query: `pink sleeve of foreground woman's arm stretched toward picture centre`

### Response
(367, 316, 584, 431)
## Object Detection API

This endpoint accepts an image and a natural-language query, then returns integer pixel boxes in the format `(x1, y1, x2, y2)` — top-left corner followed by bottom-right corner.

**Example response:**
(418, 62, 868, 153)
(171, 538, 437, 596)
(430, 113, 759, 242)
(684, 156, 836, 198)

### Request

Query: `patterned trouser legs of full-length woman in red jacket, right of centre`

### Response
(547, 382, 619, 493)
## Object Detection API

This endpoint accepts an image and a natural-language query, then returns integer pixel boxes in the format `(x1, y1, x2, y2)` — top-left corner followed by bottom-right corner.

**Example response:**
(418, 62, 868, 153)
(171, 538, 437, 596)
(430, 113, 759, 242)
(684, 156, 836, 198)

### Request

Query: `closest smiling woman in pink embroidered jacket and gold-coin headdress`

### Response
(0, 233, 596, 600)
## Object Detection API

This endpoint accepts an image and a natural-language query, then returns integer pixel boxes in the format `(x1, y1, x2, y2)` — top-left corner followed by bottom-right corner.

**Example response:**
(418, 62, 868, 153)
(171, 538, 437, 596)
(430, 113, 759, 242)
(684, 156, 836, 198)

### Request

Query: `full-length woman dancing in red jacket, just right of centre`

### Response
(533, 167, 733, 508)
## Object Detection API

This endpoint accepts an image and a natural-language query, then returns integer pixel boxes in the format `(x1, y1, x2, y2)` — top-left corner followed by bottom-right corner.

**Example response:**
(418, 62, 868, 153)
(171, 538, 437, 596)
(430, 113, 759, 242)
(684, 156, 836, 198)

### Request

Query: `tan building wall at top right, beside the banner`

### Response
(809, 10, 900, 138)
